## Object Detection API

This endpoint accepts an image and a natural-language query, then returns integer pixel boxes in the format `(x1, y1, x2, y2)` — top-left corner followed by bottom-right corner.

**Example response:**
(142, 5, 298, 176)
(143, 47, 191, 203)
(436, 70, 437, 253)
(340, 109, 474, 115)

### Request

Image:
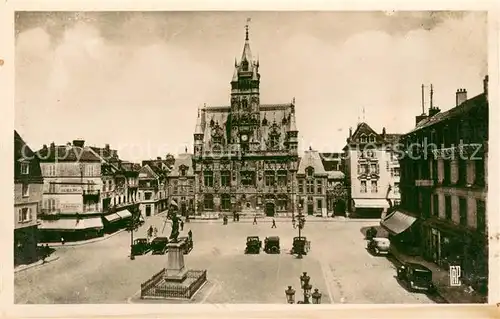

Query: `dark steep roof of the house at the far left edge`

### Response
(14, 130, 43, 183)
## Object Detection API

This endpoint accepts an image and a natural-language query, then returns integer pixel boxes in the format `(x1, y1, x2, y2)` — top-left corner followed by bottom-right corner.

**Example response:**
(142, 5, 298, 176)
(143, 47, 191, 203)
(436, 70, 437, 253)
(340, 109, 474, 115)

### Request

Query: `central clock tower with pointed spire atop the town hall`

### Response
(229, 25, 261, 151)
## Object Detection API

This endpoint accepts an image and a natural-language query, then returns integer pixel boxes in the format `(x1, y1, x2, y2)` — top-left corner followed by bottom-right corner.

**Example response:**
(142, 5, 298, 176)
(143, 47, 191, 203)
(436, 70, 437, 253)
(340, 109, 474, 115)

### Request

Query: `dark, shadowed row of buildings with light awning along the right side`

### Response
(381, 76, 489, 296)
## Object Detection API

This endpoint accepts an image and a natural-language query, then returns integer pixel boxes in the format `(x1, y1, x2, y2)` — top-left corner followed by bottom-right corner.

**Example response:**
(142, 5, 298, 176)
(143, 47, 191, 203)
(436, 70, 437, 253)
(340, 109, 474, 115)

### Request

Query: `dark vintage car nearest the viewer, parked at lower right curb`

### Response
(397, 263, 436, 293)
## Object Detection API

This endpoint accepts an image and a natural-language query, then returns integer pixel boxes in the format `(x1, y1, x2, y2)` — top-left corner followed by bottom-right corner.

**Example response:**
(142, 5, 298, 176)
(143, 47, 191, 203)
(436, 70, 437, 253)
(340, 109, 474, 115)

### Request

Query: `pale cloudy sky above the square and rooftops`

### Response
(15, 11, 488, 161)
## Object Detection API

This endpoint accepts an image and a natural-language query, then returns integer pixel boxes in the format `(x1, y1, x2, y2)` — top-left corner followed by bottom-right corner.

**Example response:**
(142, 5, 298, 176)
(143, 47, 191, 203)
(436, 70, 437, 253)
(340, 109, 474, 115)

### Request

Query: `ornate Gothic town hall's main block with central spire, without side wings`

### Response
(189, 30, 298, 216)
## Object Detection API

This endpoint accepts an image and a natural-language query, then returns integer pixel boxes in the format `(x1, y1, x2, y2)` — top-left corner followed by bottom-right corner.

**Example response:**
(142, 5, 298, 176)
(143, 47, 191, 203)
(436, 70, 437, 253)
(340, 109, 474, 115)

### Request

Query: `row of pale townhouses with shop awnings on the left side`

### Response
(14, 136, 174, 258)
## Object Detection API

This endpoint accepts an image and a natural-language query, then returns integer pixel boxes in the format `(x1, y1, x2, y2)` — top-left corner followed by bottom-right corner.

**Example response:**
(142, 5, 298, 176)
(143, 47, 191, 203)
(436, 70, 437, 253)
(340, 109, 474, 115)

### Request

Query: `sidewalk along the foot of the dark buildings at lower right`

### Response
(391, 247, 488, 304)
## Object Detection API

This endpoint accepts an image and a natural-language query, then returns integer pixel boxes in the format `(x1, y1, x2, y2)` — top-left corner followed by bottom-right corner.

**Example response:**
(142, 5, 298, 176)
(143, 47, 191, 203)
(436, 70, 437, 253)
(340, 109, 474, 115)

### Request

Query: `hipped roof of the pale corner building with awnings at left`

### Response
(36, 145, 101, 163)
